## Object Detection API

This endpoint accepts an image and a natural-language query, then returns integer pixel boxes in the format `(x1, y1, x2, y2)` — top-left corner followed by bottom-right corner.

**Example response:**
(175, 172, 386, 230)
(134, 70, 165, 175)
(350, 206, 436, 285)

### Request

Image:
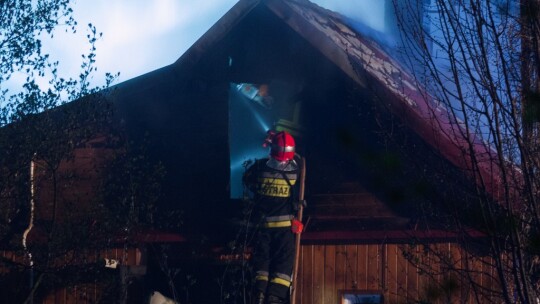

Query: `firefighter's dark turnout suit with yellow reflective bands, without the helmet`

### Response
(244, 159, 298, 299)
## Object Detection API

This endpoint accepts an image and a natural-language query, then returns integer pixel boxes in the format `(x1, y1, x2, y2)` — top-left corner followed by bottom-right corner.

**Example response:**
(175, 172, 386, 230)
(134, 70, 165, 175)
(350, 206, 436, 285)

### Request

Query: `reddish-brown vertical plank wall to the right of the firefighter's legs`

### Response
(296, 243, 497, 304)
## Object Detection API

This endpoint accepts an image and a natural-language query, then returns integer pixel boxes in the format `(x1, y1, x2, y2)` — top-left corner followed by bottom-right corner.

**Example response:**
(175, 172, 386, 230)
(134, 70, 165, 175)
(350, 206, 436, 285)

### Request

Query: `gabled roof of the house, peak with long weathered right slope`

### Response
(173, 0, 503, 204)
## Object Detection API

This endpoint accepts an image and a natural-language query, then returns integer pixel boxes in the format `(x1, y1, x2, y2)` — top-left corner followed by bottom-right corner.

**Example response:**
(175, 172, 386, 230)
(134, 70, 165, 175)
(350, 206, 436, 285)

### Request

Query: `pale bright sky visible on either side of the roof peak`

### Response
(8, 0, 384, 91)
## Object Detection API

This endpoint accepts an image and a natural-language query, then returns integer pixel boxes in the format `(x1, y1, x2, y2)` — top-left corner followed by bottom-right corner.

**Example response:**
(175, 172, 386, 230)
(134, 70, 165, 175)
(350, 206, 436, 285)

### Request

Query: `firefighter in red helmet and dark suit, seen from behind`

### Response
(243, 131, 302, 304)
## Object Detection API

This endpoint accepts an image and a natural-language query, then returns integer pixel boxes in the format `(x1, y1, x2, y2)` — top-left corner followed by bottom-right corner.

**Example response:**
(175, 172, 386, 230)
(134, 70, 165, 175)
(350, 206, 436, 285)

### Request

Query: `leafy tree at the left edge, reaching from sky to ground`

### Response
(0, 0, 122, 302)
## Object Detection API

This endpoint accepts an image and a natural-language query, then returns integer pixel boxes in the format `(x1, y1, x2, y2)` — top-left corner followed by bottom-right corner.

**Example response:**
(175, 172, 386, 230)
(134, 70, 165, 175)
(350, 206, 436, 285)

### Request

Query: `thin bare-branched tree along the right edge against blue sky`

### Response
(393, 0, 540, 303)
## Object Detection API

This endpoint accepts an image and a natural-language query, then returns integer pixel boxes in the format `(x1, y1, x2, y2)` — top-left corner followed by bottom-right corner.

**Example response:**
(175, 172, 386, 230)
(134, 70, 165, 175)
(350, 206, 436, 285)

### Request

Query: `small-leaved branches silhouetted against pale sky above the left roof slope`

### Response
(0, 0, 119, 127)
